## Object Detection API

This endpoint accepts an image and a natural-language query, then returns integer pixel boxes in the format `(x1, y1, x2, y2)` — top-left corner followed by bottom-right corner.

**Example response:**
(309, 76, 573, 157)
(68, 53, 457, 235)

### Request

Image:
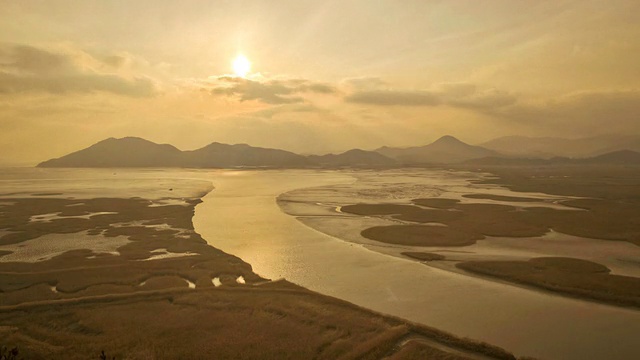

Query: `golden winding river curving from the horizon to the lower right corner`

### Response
(194, 170, 640, 359)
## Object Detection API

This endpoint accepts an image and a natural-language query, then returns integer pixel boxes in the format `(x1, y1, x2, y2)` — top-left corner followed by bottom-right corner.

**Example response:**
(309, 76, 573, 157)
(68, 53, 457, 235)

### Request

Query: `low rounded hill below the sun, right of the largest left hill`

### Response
(183, 142, 310, 168)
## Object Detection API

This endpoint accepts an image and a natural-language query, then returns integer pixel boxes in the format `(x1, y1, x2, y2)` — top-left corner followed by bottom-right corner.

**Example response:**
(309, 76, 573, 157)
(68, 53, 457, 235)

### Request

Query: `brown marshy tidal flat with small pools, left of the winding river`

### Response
(0, 170, 514, 359)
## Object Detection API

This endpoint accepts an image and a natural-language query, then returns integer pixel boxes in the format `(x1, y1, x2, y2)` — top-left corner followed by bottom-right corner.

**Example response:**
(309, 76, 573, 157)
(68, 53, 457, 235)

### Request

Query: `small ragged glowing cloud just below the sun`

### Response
(211, 76, 336, 105)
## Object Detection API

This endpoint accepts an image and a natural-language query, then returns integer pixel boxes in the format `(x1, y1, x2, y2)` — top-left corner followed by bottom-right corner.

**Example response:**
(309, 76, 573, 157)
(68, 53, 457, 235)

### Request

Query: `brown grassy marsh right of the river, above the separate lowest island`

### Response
(342, 168, 640, 246)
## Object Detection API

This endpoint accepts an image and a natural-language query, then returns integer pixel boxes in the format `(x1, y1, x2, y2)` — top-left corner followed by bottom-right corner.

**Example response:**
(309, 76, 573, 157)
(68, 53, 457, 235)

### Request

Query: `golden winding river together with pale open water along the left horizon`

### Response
(0, 169, 640, 359)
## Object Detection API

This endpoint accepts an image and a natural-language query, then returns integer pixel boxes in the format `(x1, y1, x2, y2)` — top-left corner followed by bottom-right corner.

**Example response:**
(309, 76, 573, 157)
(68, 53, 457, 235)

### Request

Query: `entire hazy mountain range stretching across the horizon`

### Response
(38, 136, 640, 168)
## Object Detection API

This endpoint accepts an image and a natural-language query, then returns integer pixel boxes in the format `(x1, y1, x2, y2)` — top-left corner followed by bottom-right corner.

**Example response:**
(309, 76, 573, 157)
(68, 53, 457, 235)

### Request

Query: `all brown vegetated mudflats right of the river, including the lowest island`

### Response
(341, 166, 640, 306)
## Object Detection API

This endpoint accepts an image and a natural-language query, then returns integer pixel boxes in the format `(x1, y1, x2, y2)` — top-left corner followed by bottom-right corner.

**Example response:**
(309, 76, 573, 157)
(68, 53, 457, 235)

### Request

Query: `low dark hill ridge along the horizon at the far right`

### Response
(465, 150, 640, 166)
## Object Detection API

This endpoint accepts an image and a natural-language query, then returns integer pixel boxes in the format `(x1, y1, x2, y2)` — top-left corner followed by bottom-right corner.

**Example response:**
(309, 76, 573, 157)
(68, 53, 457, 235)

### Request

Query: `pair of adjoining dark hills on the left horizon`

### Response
(38, 137, 310, 168)
